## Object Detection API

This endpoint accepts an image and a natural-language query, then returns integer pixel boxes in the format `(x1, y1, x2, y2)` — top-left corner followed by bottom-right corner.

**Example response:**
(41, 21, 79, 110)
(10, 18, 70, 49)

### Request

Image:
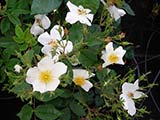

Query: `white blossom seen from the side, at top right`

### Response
(108, 5, 126, 21)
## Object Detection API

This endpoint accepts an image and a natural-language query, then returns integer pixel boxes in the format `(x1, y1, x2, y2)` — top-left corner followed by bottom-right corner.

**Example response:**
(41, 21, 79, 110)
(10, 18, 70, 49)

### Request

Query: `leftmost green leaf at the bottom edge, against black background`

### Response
(17, 105, 33, 120)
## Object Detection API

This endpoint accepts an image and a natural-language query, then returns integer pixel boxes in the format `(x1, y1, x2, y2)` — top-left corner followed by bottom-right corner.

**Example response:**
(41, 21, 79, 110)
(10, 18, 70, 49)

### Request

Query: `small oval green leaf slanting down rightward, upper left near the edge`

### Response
(7, 13, 21, 25)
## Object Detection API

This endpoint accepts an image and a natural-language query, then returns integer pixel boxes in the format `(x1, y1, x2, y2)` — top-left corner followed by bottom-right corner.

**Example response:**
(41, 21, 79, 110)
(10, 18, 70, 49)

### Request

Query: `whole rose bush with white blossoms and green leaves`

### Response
(0, 0, 152, 120)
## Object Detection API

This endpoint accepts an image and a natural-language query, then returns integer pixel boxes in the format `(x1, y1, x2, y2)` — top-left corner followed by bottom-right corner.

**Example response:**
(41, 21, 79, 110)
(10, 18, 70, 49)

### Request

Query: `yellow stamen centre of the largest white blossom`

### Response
(39, 70, 53, 83)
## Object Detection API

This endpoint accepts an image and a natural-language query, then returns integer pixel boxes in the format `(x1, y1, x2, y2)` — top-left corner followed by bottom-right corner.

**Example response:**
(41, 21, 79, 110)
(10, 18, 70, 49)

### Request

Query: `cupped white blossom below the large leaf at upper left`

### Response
(30, 14, 51, 36)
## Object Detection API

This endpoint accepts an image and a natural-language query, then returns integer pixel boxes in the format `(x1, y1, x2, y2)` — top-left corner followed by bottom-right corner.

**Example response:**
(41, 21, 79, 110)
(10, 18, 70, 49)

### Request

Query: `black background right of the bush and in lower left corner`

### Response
(0, 0, 160, 120)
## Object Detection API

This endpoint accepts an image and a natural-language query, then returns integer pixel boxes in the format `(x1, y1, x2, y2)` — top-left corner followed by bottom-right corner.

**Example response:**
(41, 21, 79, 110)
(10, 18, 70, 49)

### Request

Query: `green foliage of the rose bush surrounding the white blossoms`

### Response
(0, 0, 153, 120)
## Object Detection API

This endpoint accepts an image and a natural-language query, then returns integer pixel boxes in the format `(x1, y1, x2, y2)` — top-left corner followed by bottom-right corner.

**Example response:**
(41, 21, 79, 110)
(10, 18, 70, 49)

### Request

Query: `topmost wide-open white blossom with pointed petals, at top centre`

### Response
(65, 1, 93, 26)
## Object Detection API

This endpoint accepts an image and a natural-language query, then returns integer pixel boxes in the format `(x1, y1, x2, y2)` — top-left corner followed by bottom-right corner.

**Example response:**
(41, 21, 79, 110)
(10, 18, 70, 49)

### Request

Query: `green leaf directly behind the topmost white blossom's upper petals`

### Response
(70, 0, 100, 14)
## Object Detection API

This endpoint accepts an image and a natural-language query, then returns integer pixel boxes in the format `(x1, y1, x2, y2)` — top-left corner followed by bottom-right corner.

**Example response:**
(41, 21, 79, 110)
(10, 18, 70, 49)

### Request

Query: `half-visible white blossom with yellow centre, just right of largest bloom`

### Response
(73, 69, 94, 92)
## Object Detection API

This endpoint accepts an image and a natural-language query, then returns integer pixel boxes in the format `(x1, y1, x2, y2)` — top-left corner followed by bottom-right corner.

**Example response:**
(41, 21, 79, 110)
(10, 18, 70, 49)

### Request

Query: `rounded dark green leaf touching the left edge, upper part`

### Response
(0, 18, 10, 34)
